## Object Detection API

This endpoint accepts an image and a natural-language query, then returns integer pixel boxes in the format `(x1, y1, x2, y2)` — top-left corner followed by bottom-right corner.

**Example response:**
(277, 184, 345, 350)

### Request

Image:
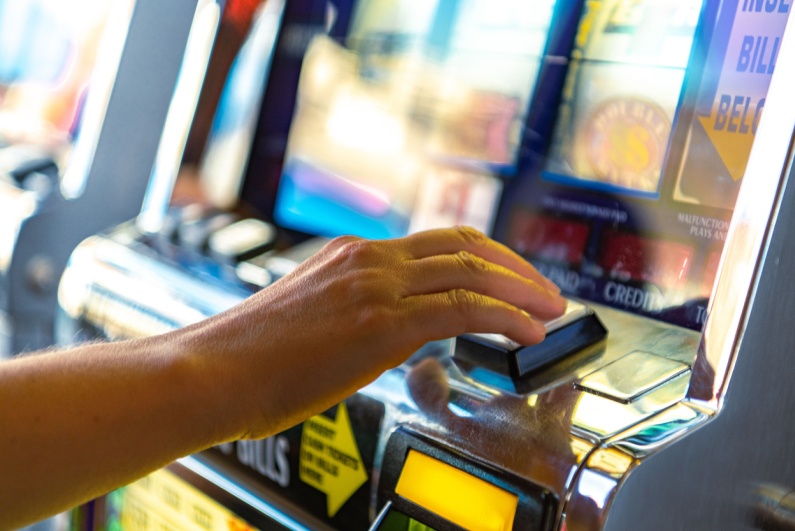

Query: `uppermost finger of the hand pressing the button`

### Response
(405, 226, 560, 294)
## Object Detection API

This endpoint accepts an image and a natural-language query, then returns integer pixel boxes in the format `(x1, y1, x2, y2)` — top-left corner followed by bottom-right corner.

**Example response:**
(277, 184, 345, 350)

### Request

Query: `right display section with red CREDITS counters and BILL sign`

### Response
(496, 0, 791, 330)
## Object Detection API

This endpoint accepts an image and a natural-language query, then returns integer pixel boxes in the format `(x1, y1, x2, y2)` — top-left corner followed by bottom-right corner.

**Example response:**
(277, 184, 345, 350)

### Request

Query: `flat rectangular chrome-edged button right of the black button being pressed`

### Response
(577, 350, 690, 404)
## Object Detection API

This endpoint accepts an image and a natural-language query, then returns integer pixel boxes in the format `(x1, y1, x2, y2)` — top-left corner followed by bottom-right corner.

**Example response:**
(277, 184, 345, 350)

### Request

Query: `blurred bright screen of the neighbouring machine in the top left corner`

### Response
(0, 0, 126, 159)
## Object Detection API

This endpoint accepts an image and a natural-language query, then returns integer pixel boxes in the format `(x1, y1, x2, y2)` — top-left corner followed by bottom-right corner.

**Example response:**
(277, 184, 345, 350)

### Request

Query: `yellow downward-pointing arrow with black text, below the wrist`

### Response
(298, 402, 367, 518)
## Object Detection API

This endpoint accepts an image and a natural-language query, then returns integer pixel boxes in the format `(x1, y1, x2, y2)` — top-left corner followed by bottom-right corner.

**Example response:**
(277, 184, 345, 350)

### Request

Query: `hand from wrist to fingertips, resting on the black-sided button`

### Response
(180, 228, 565, 437)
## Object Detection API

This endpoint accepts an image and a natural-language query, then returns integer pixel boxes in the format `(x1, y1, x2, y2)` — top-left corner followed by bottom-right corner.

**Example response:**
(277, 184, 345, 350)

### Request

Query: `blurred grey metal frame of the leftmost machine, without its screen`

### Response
(0, 0, 218, 356)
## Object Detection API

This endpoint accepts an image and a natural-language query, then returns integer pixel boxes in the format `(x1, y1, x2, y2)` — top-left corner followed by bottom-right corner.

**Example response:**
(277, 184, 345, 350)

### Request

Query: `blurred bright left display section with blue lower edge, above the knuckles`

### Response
(274, 0, 560, 238)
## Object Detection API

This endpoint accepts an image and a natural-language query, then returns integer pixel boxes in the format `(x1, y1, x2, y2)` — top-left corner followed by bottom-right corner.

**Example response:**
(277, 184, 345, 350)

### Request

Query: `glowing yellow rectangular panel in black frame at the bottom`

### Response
(395, 450, 519, 531)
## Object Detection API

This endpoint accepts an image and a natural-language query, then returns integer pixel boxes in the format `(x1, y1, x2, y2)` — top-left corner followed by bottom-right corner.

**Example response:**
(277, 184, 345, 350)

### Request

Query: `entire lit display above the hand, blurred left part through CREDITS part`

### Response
(264, 0, 791, 330)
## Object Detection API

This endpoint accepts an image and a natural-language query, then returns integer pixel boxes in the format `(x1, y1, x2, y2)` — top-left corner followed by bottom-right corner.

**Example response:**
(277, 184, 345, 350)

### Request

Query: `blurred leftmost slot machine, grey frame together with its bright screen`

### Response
(0, 0, 219, 357)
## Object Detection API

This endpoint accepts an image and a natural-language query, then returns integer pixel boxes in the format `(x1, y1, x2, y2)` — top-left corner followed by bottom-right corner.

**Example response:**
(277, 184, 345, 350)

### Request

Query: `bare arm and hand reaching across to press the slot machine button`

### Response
(0, 229, 565, 527)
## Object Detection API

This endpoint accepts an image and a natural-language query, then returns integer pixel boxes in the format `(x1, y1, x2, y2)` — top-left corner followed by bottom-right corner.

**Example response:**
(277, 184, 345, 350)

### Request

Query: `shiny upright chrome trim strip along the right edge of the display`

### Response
(687, 11, 795, 411)
